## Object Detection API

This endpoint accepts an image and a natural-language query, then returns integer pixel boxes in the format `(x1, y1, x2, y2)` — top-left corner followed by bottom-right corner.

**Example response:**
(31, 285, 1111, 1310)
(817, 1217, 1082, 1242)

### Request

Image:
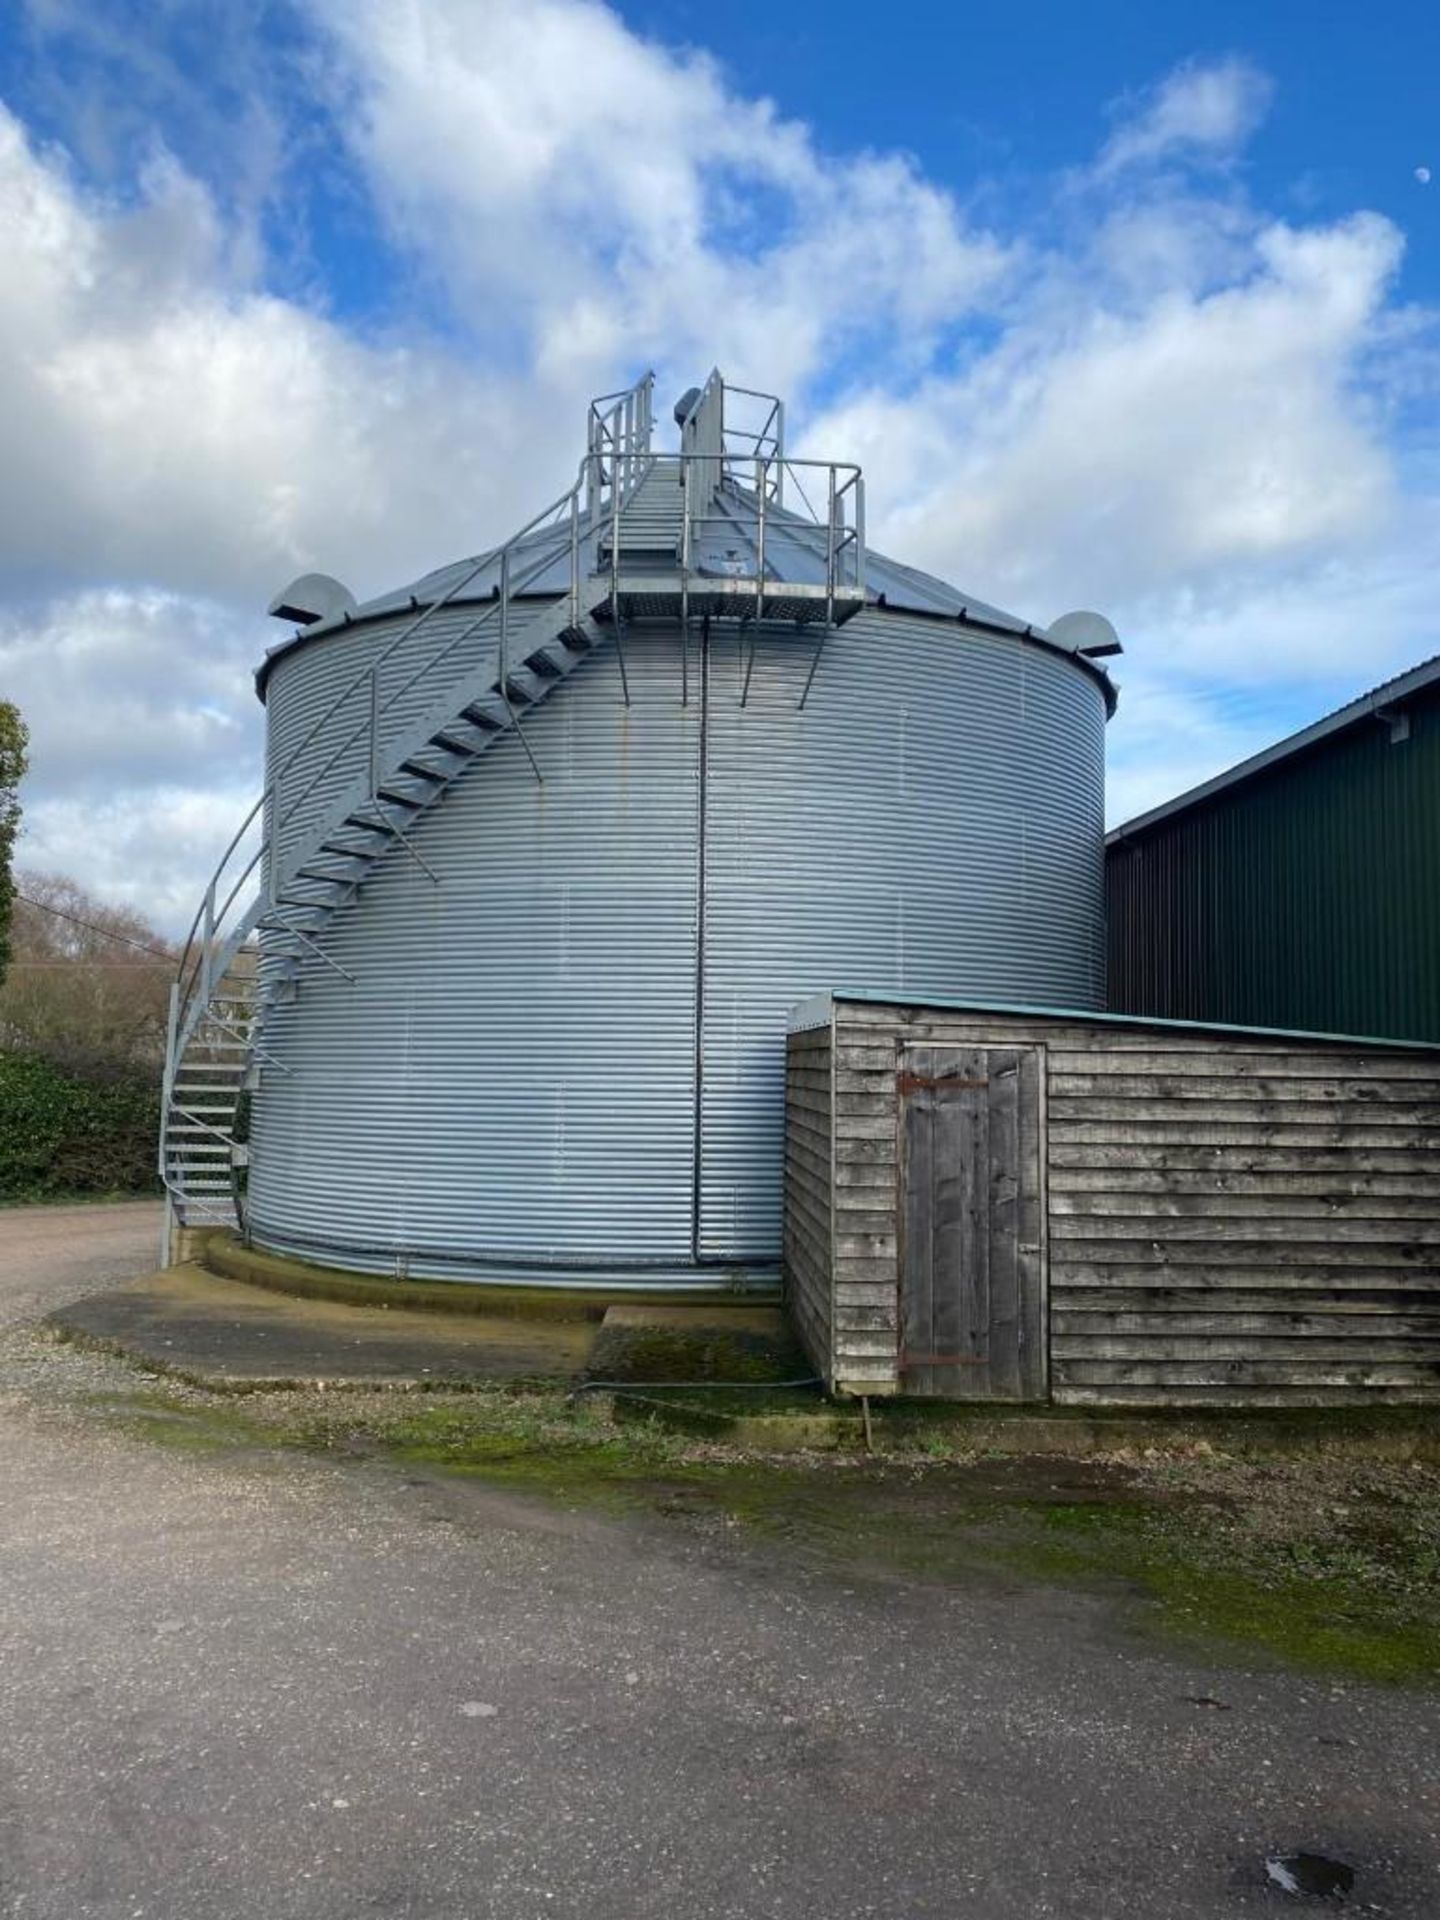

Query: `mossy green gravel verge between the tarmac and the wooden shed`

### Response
(87, 1386, 1440, 1684)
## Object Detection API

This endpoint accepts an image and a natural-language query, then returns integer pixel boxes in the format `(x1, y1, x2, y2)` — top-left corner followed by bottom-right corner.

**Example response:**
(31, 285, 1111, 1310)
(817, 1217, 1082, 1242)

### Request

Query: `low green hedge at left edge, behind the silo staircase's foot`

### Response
(0, 1052, 159, 1202)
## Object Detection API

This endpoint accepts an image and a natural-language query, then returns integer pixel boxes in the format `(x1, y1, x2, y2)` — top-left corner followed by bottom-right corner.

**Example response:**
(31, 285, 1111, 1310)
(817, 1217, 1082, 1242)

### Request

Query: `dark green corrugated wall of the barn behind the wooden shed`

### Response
(1106, 695, 1440, 1041)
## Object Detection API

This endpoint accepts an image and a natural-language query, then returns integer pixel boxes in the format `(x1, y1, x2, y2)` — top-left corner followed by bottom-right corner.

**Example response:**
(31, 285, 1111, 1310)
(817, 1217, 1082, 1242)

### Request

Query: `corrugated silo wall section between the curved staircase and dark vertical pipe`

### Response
(250, 637, 699, 1271)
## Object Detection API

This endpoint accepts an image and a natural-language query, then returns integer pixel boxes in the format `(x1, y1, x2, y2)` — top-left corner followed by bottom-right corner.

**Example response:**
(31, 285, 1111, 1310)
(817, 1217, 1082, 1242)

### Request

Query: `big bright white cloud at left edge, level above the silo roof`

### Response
(0, 106, 595, 607)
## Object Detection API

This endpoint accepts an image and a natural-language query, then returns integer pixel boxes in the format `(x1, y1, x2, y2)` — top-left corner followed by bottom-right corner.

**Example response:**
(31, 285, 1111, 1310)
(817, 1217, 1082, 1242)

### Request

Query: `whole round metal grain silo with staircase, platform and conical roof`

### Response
(165, 374, 1114, 1288)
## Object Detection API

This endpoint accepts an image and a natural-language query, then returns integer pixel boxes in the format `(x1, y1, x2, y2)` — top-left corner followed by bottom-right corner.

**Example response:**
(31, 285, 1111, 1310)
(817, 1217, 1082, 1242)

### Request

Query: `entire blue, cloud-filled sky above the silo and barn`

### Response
(0, 0, 1440, 920)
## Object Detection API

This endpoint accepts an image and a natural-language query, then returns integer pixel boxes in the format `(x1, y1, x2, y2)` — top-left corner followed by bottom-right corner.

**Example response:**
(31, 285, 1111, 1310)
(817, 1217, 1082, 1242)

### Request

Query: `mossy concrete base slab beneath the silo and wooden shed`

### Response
(50, 1233, 1440, 1461)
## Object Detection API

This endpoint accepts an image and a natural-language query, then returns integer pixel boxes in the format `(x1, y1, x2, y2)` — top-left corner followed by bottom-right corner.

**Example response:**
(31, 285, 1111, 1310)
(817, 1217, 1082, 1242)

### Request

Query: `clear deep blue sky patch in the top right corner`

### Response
(641, 0, 1440, 276)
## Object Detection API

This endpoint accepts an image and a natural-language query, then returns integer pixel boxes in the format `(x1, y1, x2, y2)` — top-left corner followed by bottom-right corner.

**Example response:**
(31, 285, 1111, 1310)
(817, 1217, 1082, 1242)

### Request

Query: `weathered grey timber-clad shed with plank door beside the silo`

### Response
(785, 998, 1440, 1405)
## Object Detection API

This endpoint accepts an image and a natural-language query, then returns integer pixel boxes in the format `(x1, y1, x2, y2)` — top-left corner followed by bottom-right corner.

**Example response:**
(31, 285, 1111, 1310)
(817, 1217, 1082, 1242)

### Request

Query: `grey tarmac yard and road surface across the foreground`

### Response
(0, 1208, 1440, 1920)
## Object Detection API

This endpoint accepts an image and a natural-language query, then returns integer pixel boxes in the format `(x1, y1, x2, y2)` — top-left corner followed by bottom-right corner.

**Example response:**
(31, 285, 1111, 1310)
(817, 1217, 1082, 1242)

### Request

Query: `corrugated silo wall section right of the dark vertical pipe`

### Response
(701, 611, 1106, 1254)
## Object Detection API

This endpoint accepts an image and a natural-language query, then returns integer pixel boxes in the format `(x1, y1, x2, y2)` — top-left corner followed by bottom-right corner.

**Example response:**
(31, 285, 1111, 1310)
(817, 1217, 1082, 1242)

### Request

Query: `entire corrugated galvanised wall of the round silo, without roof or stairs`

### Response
(250, 609, 1104, 1273)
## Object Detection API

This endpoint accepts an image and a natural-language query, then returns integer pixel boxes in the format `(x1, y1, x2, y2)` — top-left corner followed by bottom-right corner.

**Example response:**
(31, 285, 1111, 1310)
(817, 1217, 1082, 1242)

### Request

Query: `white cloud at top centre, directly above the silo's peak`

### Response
(305, 0, 1008, 394)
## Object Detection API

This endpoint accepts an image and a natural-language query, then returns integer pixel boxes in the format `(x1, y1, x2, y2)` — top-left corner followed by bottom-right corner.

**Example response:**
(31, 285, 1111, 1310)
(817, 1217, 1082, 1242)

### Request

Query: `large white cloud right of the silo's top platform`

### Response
(814, 215, 1400, 641)
